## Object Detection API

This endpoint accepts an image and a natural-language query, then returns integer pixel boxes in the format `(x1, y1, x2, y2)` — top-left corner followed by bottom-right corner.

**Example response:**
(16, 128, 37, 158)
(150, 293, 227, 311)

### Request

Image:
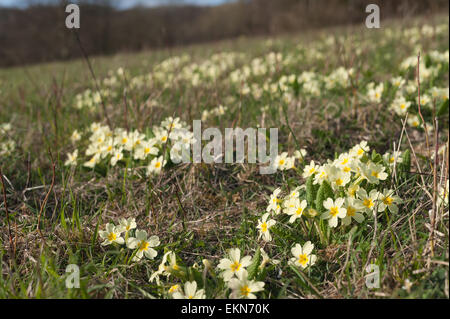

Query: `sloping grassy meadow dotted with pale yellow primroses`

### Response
(0, 15, 449, 299)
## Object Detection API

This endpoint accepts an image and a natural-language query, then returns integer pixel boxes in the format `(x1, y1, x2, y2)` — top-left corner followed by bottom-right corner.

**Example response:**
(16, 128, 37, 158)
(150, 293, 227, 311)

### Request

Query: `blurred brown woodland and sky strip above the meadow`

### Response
(0, 0, 448, 67)
